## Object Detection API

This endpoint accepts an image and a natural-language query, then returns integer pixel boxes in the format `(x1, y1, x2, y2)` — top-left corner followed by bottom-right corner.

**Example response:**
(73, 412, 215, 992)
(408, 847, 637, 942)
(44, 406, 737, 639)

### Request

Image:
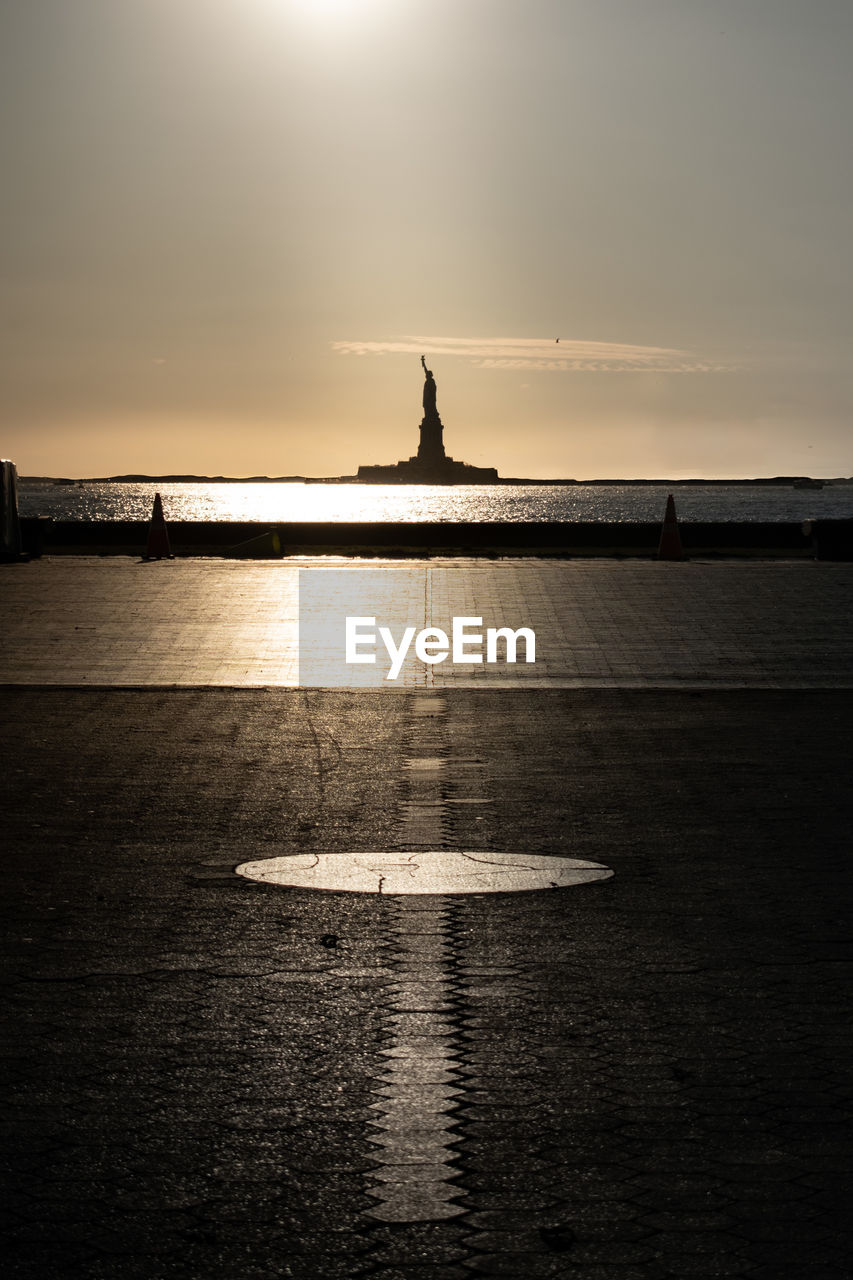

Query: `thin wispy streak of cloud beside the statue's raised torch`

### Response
(332, 334, 731, 374)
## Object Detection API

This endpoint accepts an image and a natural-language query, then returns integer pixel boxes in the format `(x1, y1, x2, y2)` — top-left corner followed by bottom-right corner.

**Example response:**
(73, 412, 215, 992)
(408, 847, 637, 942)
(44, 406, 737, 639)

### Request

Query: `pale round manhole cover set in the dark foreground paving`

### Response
(230, 850, 613, 893)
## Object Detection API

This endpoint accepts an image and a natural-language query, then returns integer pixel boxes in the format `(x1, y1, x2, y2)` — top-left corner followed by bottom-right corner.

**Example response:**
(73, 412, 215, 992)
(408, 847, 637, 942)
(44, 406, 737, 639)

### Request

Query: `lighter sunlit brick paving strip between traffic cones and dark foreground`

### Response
(0, 558, 853, 689)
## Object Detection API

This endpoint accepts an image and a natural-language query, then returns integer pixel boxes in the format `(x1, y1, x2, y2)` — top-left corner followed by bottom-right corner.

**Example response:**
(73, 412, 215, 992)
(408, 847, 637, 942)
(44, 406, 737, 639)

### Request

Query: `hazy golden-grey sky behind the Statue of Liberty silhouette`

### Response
(0, 0, 853, 477)
